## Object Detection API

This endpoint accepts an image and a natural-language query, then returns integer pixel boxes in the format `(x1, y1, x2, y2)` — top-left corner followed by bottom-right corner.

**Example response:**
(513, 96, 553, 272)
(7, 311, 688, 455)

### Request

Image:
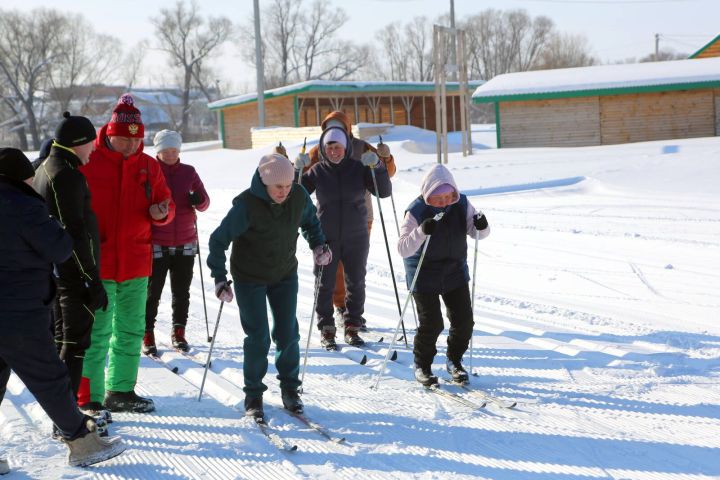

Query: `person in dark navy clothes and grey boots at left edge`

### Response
(0, 148, 125, 465)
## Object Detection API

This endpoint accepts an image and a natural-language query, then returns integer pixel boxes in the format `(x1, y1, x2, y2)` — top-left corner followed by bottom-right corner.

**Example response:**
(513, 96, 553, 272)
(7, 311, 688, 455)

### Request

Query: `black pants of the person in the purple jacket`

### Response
(145, 254, 195, 331)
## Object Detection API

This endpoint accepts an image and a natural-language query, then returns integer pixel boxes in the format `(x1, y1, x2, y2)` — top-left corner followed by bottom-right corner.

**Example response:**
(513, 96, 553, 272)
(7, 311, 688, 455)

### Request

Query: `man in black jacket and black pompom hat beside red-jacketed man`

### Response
(33, 112, 108, 415)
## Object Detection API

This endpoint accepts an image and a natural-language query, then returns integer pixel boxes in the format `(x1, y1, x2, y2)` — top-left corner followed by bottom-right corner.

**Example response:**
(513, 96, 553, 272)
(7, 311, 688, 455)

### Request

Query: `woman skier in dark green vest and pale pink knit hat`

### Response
(207, 154, 332, 419)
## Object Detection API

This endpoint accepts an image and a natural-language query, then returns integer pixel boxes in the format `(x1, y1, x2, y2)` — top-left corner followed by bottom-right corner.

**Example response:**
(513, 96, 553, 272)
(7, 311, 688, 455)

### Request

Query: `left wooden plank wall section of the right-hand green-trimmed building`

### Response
(500, 97, 600, 147)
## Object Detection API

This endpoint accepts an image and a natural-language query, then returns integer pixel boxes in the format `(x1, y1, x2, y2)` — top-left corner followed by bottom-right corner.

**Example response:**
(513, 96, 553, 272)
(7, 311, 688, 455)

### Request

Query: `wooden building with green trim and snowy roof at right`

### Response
(473, 58, 720, 148)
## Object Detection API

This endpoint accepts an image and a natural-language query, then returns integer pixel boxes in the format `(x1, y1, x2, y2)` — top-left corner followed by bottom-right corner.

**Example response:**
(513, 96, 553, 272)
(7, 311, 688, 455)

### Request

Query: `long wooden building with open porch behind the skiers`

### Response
(208, 80, 482, 149)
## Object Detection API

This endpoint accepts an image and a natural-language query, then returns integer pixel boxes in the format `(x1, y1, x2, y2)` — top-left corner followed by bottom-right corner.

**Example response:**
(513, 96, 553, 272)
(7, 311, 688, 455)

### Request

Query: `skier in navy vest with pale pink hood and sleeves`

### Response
(398, 165, 490, 386)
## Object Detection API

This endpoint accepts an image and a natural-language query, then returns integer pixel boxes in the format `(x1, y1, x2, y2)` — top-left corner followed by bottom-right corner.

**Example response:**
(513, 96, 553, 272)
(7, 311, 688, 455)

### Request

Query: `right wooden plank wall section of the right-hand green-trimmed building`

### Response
(600, 90, 716, 145)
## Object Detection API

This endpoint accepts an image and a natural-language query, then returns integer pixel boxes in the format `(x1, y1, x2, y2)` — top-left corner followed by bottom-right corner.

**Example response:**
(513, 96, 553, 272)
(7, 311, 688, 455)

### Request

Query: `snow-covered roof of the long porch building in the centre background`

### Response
(208, 80, 483, 110)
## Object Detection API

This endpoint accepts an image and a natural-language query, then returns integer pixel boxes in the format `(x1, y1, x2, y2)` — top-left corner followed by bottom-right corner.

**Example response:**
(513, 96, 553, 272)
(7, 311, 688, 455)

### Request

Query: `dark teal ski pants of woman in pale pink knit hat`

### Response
(234, 271, 300, 397)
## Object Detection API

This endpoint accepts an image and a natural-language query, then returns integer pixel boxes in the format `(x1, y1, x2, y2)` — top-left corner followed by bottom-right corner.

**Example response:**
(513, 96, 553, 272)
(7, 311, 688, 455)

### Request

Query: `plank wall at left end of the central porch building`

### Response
(224, 96, 295, 149)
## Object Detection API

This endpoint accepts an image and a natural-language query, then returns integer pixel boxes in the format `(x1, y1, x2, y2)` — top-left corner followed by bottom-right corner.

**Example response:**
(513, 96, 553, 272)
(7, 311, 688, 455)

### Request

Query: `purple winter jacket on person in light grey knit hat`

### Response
(152, 160, 210, 247)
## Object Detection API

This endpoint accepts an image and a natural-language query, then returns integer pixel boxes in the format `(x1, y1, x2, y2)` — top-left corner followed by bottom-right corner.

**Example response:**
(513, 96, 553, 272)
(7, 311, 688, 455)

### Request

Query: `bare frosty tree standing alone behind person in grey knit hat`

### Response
(151, 0, 233, 135)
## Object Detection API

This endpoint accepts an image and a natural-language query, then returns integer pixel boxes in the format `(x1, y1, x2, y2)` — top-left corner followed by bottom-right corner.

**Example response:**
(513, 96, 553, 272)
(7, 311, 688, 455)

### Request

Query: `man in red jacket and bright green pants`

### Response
(78, 93, 175, 413)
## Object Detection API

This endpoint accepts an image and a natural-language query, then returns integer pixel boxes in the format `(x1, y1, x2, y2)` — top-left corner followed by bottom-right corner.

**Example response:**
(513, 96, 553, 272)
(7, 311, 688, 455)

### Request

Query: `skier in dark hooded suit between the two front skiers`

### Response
(298, 127, 392, 350)
